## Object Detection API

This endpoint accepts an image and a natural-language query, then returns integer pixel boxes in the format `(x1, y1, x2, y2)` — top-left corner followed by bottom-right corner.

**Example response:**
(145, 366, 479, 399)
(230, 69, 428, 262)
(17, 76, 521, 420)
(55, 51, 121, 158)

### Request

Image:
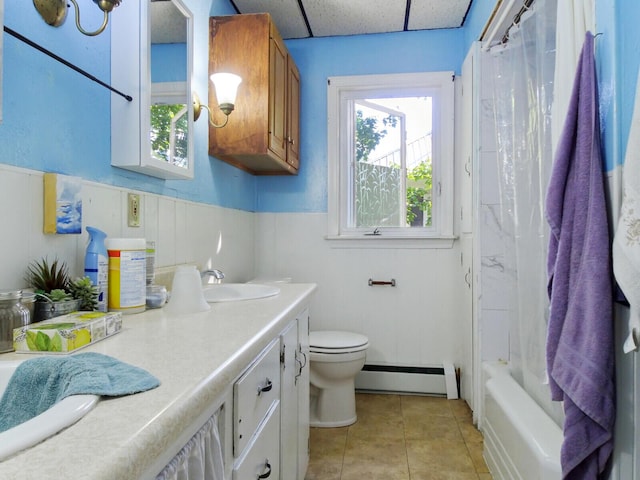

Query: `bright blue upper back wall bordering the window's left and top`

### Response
(257, 29, 465, 212)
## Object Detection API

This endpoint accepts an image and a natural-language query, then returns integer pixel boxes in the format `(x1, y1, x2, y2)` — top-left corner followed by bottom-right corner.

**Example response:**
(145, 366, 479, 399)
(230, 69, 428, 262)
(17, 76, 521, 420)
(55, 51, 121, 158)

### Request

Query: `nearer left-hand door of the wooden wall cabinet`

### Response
(269, 34, 287, 161)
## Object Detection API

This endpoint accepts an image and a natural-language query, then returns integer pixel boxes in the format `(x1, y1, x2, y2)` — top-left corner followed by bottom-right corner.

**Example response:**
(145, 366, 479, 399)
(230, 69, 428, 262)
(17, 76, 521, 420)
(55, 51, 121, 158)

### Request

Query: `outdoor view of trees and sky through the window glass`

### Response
(353, 97, 433, 228)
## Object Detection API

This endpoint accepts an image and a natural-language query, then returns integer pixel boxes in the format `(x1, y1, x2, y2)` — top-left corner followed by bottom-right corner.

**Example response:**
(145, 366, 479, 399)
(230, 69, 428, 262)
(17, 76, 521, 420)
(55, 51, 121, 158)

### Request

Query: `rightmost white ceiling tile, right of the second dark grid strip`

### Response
(408, 0, 471, 30)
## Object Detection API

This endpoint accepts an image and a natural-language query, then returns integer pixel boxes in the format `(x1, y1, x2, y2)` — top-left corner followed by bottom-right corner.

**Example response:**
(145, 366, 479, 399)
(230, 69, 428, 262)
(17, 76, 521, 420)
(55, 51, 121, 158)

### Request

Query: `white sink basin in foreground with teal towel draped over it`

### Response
(0, 360, 100, 461)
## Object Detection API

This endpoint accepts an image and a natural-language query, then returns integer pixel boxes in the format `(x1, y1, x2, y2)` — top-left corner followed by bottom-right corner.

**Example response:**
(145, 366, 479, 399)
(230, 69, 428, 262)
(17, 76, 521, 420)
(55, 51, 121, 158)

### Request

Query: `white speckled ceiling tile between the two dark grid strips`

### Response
(302, 0, 407, 37)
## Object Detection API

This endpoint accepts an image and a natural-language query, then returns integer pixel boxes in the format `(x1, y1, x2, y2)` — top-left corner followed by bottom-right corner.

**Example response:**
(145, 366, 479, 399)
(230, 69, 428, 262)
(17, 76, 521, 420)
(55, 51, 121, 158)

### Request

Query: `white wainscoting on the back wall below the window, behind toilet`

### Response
(255, 213, 471, 388)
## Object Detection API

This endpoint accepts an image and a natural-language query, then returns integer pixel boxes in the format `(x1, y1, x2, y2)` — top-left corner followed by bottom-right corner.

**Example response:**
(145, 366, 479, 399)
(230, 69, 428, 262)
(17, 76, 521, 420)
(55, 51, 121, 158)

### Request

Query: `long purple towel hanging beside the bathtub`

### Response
(546, 33, 615, 480)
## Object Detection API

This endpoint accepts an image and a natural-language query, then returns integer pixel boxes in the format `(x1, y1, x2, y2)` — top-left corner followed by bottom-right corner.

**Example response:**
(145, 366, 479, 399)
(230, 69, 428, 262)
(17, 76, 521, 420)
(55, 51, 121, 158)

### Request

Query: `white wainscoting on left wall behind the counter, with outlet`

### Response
(0, 165, 254, 289)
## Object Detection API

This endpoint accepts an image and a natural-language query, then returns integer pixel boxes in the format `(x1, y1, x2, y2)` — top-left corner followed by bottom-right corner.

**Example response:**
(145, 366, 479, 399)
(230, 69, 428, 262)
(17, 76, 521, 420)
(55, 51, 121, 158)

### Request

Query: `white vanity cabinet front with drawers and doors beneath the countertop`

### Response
(163, 309, 309, 480)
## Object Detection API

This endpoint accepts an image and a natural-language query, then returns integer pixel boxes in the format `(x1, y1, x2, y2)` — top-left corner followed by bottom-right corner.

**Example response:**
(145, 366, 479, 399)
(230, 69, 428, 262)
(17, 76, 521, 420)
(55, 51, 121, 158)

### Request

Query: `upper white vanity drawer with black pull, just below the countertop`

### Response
(233, 338, 280, 457)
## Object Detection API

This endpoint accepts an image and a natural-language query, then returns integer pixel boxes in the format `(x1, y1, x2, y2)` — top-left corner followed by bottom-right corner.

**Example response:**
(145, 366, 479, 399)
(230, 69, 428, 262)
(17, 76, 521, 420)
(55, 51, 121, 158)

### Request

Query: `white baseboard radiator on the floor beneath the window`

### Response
(356, 362, 459, 399)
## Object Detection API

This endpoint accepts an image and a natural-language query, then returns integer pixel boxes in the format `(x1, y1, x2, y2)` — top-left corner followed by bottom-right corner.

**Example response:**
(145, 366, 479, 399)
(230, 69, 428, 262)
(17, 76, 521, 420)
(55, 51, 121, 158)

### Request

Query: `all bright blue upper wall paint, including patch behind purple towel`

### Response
(0, 0, 640, 212)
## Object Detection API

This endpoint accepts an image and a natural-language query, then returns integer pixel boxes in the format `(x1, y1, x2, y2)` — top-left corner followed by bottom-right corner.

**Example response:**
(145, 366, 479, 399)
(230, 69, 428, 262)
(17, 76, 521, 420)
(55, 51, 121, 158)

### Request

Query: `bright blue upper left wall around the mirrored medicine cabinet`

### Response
(0, 0, 256, 211)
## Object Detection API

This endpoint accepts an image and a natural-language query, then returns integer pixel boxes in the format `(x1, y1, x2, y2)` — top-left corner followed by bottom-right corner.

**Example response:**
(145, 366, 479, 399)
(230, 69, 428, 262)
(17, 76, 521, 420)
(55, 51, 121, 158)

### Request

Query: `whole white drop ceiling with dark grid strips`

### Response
(231, 0, 473, 39)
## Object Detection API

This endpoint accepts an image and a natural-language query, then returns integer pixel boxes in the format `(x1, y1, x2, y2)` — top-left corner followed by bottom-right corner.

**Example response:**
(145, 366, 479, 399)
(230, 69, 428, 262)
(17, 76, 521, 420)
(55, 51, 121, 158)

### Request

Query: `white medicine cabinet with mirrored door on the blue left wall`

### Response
(111, 0, 194, 179)
